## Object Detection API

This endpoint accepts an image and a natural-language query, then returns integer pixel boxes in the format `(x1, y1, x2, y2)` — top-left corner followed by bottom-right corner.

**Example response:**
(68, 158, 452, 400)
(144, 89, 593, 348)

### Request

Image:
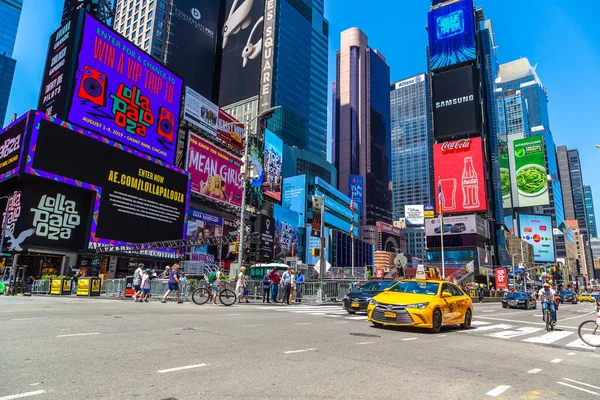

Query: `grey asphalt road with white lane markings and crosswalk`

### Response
(0, 296, 600, 400)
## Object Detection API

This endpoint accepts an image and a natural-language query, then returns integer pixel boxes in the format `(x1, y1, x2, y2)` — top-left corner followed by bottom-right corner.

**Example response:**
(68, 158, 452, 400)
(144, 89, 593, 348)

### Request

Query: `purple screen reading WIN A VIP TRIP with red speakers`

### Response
(67, 14, 182, 164)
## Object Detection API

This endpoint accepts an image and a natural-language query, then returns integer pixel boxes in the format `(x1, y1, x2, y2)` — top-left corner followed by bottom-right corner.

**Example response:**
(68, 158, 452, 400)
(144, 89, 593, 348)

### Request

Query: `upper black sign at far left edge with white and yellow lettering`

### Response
(0, 114, 27, 182)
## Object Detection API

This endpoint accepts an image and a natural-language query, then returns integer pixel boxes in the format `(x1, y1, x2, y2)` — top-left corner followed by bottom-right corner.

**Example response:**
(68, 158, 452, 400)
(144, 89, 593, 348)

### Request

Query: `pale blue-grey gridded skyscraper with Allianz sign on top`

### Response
(390, 74, 433, 220)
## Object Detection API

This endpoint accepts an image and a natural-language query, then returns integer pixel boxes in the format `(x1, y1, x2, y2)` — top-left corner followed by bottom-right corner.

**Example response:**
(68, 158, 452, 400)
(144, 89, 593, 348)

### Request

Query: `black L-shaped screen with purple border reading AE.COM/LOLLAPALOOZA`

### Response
(25, 113, 189, 256)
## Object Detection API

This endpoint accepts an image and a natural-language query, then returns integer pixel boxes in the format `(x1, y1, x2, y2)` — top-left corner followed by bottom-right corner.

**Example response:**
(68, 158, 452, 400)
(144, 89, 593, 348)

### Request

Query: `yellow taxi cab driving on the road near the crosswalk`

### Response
(367, 279, 473, 333)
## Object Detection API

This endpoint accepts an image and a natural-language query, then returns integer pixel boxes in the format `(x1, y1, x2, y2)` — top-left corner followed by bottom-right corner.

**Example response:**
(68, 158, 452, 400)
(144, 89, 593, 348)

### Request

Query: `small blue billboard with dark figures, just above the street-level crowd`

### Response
(273, 204, 300, 260)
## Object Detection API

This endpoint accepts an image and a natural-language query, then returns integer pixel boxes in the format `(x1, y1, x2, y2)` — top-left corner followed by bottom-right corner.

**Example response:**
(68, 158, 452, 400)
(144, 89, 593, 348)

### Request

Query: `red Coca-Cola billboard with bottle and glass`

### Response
(433, 137, 487, 213)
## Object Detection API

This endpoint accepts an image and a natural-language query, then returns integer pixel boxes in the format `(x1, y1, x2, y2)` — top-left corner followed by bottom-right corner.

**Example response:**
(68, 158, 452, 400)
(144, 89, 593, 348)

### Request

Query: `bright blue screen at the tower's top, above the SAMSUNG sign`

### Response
(428, 0, 477, 70)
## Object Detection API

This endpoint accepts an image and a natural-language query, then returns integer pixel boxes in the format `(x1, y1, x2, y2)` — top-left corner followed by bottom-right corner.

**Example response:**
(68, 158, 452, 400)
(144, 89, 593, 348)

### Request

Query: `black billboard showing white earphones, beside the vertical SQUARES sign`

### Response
(219, 0, 265, 106)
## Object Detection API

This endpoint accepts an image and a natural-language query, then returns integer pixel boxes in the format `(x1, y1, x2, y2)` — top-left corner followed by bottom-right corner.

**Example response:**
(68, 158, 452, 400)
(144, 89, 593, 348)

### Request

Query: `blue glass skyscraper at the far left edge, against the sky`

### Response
(0, 0, 23, 122)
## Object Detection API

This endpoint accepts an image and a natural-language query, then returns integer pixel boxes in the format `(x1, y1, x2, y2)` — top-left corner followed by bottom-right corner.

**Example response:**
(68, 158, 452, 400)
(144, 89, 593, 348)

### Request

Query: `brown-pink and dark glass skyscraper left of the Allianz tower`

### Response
(332, 28, 392, 226)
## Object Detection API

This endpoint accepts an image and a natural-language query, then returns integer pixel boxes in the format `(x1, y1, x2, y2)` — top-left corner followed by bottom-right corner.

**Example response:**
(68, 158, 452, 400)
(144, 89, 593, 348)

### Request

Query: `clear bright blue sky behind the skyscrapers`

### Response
(7, 0, 600, 228)
